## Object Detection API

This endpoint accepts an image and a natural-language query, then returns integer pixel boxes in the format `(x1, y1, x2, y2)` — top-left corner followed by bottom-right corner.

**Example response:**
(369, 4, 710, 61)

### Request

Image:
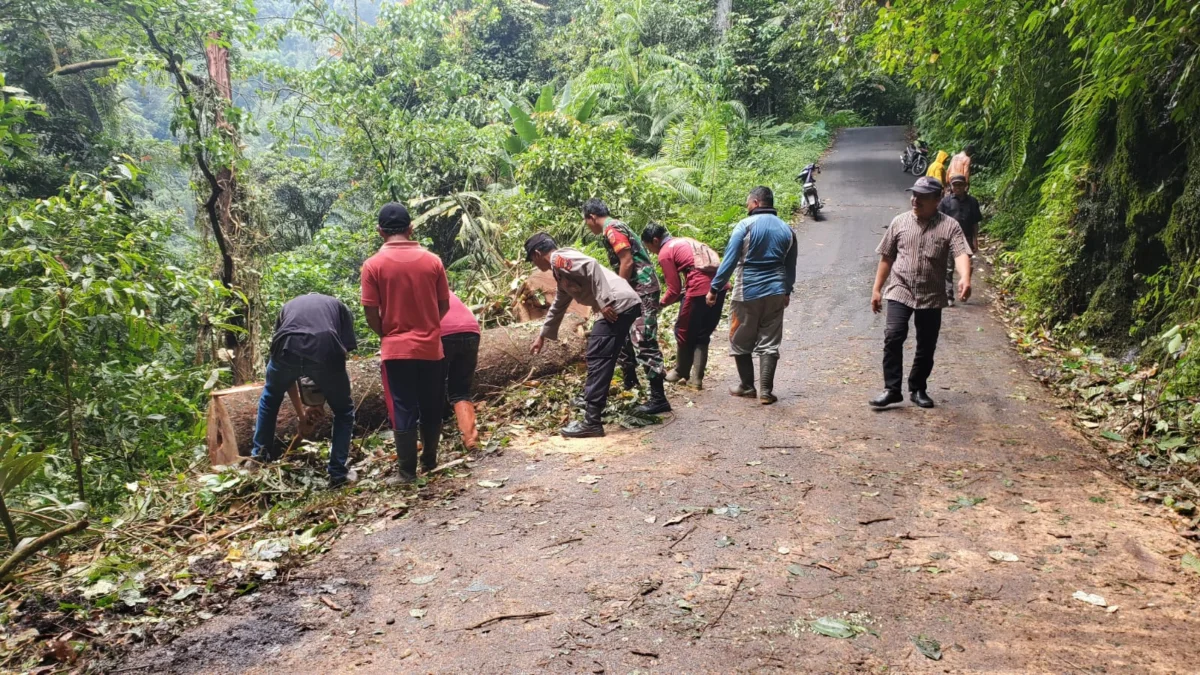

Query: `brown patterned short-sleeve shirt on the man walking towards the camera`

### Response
(875, 211, 971, 310)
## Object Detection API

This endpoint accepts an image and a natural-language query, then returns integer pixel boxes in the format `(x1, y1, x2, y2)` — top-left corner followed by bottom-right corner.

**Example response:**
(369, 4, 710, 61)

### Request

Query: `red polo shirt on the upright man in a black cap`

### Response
(362, 241, 450, 360)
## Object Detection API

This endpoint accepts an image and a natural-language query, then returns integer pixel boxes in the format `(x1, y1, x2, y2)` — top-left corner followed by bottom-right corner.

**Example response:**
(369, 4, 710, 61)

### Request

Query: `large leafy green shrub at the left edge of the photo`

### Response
(0, 161, 220, 498)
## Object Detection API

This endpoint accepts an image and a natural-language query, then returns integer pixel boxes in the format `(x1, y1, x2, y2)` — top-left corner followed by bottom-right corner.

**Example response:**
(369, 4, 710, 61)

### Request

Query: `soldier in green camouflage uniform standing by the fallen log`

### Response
(583, 198, 671, 414)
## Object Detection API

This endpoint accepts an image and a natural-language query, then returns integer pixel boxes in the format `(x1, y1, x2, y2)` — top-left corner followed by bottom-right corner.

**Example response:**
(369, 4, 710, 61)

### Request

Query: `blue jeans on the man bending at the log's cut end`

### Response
(250, 354, 354, 483)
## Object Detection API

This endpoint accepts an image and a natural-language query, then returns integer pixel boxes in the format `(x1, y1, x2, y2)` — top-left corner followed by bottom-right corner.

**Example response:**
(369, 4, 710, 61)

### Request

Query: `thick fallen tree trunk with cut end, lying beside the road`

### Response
(208, 315, 587, 465)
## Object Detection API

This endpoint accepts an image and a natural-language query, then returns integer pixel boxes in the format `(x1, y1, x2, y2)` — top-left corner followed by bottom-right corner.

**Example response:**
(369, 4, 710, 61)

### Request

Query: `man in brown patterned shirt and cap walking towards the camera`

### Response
(870, 175, 971, 408)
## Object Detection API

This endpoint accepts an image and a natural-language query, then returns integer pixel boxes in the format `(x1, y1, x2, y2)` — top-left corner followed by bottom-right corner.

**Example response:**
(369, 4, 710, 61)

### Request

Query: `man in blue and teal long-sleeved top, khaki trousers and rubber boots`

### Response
(708, 186, 796, 406)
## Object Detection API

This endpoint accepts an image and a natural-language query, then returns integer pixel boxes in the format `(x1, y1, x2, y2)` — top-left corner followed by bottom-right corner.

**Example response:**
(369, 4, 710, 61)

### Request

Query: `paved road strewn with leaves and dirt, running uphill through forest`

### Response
(128, 129, 1200, 674)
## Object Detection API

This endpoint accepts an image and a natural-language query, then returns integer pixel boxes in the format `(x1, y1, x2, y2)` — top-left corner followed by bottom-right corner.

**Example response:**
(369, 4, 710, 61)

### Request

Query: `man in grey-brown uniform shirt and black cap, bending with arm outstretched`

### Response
(524, 232, 642, 438)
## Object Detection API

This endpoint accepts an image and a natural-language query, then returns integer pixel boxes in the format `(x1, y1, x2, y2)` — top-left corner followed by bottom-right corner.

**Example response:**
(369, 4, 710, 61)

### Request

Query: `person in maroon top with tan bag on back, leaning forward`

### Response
(642, 222, 725, 389)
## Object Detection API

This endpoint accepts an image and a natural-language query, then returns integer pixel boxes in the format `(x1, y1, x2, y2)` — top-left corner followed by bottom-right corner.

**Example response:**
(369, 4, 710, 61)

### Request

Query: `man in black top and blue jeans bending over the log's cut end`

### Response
(250, 293, 358, 488)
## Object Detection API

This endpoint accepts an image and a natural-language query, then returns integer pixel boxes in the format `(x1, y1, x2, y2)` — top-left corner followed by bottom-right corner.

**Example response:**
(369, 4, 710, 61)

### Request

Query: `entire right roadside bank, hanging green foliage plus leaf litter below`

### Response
(865, 0, 1200, 532)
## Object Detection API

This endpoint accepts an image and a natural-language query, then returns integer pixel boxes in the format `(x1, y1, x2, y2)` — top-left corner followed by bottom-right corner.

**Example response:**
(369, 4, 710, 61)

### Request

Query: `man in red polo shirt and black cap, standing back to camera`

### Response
(362, 203, 450, 483)
